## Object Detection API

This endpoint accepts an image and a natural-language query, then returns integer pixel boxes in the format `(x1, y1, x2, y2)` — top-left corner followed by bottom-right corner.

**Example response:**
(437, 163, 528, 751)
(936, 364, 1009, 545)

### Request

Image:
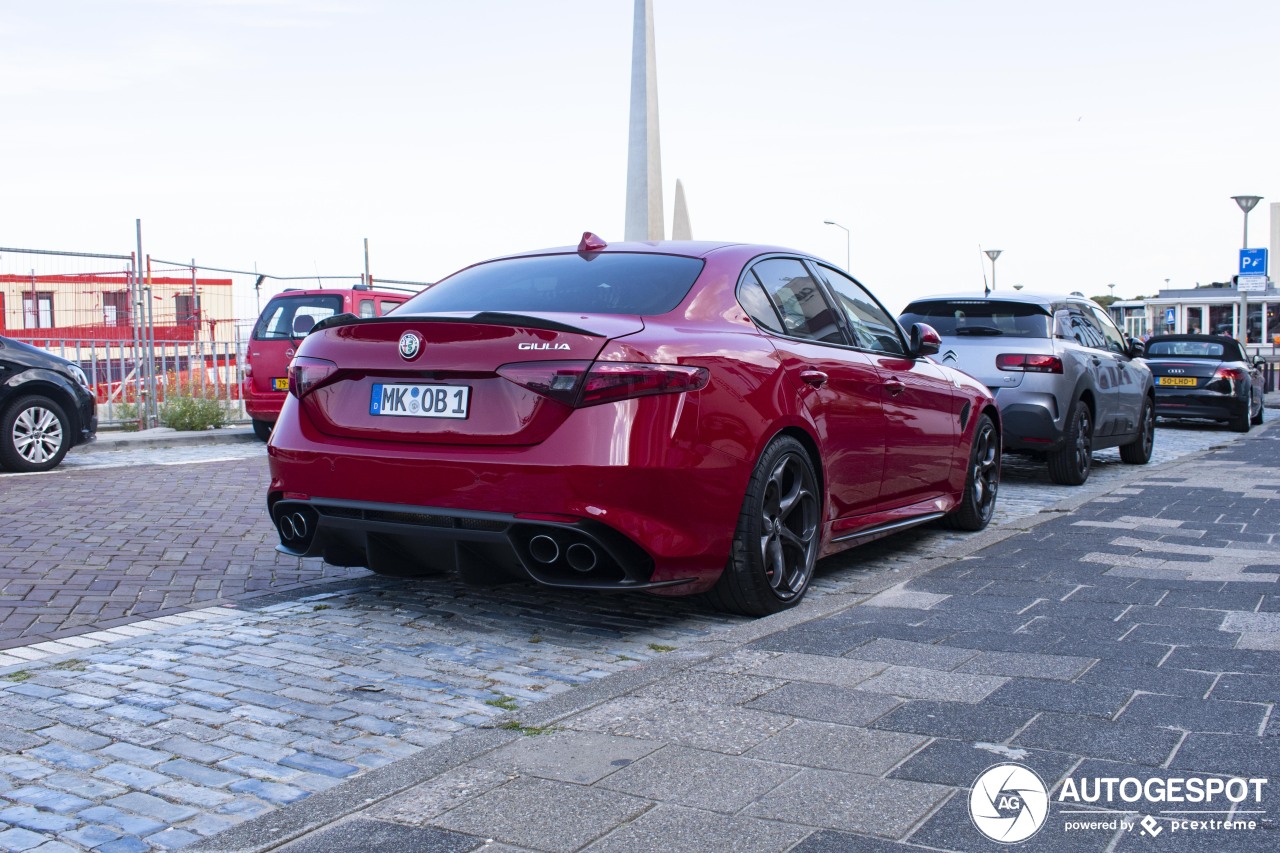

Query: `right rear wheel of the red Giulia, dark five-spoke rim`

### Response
(708, 435, 822, 616)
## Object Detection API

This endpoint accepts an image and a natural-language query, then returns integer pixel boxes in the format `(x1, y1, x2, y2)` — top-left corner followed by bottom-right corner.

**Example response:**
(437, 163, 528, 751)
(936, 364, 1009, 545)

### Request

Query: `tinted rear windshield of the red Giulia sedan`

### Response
(397, 252, 703, 314)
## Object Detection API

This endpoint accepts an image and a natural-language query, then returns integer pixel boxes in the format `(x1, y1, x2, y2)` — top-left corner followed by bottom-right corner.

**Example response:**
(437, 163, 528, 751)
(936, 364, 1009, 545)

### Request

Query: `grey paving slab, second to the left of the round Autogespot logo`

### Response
(596, 747, 799, 813)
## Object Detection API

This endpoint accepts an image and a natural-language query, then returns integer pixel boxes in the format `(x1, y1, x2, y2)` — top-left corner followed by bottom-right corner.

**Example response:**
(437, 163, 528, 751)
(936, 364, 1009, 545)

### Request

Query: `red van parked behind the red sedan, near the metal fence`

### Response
(242, 284, 416, 442)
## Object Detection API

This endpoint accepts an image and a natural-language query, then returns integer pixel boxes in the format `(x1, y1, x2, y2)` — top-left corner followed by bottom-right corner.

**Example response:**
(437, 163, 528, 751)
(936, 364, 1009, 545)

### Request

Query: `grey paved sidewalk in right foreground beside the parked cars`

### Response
(186, 427, 1280, 853)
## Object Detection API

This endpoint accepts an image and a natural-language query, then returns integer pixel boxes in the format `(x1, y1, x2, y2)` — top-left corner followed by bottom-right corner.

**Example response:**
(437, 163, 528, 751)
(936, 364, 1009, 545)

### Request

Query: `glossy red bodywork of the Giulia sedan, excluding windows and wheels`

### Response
(268, 242, 998, 612)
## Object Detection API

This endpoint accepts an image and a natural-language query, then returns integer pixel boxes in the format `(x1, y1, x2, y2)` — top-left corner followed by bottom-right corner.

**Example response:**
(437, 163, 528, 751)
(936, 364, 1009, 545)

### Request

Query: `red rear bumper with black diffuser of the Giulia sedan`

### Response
(268, 397, 750, 594)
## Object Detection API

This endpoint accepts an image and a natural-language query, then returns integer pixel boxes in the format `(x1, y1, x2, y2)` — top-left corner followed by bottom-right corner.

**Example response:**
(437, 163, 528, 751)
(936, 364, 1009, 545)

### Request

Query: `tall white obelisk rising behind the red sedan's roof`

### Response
(625, 0, 664, 241)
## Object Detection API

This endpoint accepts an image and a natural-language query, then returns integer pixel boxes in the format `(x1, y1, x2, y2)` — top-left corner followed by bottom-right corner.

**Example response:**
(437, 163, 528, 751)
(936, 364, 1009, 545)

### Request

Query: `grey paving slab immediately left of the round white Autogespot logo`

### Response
(742, 770, 951, 838)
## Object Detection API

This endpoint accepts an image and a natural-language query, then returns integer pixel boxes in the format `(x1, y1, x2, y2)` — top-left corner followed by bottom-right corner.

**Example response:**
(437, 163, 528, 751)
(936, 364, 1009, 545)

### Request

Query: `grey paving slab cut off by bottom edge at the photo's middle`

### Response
(586, 804, 809, 853)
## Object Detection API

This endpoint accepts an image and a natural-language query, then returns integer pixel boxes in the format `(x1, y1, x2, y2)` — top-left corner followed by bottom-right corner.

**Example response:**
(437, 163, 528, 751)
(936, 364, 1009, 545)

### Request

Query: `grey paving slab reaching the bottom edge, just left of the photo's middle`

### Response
(434, 779, 649, 853)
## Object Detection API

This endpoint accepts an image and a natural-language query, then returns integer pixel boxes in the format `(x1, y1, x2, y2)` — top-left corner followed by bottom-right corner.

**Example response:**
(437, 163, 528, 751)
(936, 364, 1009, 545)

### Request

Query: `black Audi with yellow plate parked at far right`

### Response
(1147, 334, 1266, 433)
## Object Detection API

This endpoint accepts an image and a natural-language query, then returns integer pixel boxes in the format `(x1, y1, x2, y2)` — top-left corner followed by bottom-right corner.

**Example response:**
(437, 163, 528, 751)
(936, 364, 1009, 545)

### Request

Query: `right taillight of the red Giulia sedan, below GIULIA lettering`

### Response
(498, 361, 710, 407)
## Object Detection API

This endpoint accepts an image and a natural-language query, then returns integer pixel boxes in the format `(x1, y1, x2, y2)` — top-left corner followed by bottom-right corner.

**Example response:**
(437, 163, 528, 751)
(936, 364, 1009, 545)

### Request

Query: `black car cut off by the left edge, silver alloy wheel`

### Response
(0, 336, 97, 471)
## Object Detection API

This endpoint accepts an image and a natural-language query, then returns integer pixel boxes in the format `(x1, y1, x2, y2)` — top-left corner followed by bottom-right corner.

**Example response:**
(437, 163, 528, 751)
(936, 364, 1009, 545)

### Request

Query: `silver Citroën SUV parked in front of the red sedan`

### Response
(899, 292, 1156, 485)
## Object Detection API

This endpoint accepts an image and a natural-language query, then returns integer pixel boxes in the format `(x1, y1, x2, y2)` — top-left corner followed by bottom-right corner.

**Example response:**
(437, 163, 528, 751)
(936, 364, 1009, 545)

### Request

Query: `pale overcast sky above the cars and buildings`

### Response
(0, 0, 1280, 311)
